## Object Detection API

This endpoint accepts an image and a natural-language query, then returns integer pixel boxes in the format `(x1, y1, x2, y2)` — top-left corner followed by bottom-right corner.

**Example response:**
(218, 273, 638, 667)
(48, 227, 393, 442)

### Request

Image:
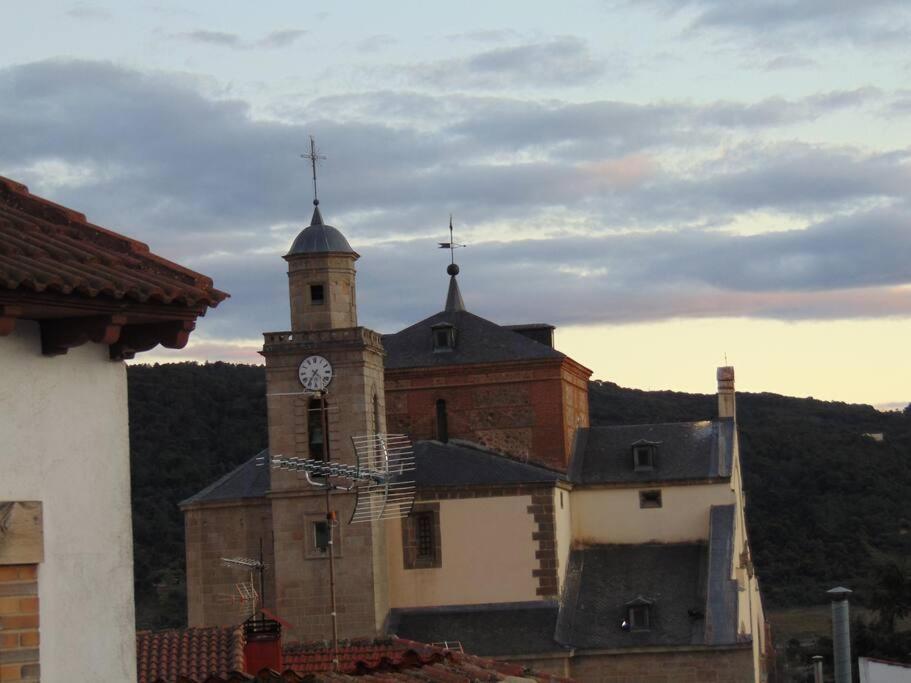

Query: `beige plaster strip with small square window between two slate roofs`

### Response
(572, 482, 735, 544)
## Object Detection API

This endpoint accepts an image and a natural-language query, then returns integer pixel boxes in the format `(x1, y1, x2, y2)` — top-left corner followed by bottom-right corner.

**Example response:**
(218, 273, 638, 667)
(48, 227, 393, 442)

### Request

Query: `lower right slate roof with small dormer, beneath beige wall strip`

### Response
(556, 543, 707, 648)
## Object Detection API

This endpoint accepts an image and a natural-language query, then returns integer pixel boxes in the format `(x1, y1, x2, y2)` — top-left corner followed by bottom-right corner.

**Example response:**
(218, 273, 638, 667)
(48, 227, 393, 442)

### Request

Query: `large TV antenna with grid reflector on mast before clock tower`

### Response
(262, 391, 416, 671)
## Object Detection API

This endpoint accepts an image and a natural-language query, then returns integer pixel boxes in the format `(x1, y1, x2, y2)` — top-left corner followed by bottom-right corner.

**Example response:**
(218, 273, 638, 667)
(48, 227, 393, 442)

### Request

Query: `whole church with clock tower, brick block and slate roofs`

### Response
(181, 202, 770, 683)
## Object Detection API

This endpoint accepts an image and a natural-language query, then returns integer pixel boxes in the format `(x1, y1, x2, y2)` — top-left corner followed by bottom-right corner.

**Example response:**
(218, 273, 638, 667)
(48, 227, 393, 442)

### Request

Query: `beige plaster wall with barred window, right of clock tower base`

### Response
(386, 496, 538, 607)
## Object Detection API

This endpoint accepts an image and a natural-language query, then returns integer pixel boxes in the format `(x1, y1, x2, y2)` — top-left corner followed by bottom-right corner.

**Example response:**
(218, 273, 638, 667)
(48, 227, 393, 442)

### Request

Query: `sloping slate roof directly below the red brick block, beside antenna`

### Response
(414, 440, 564, 487)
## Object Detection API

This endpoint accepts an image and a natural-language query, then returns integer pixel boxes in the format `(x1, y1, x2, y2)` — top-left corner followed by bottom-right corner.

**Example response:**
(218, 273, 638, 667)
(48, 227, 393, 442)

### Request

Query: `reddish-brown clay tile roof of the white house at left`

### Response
(0, 177, 228, 312)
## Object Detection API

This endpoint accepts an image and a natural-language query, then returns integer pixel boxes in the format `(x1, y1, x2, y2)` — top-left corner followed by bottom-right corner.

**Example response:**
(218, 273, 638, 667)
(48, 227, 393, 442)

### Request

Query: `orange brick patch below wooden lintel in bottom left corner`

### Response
(0, 564, 39, 683)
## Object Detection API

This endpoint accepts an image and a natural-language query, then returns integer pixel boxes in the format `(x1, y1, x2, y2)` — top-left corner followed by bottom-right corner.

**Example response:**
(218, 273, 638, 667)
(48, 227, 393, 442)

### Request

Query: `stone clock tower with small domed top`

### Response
(262, 201, 389, 640)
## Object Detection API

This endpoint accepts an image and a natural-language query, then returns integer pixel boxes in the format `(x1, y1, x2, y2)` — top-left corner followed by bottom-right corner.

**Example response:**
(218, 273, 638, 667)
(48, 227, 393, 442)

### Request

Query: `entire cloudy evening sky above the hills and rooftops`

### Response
(0, 0, 911, 408)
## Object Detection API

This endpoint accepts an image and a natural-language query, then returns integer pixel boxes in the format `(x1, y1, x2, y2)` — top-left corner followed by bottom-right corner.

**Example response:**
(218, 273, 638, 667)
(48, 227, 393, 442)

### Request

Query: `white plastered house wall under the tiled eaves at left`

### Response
(0, 321, 136, 682)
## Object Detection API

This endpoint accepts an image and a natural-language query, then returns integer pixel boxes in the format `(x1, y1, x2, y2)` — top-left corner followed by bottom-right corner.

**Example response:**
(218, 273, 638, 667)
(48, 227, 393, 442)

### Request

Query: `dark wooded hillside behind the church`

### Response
(128, 363, 911, 628)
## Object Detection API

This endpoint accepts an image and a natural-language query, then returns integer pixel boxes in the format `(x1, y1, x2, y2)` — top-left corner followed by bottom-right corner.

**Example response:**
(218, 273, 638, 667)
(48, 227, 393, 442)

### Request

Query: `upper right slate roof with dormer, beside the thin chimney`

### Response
(569, 420, 734, 484)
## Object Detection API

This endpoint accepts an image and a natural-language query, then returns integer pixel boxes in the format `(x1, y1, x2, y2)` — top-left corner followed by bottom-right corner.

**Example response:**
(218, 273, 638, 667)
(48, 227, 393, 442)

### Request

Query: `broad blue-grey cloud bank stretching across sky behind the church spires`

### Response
(0, 61, 911, 342)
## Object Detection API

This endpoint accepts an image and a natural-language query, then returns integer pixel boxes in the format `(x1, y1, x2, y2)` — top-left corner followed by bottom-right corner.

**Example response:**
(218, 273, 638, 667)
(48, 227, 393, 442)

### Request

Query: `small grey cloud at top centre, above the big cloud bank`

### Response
(409, 36, 606, 89)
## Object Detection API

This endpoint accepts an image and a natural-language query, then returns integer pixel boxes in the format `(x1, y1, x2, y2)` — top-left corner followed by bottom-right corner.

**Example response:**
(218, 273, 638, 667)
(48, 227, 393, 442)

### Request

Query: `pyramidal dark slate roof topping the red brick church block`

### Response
(383, 311, 566, 370)
